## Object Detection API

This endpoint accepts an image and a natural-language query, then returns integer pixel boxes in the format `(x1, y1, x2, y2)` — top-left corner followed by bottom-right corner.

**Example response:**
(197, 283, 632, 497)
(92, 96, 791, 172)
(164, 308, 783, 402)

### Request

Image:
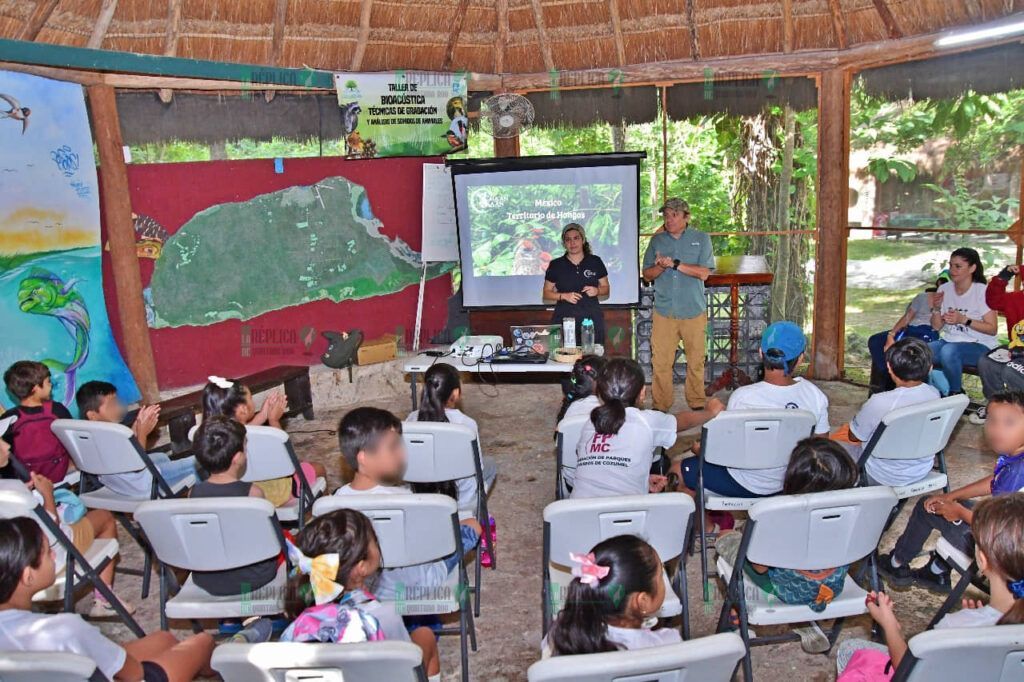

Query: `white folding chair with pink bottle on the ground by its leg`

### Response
(401, 422, 498, 616)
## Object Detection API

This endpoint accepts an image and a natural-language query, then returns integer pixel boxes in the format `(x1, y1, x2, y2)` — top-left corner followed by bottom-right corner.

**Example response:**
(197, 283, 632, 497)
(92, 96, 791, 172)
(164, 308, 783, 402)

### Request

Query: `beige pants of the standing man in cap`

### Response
(650, 312, 708, 412)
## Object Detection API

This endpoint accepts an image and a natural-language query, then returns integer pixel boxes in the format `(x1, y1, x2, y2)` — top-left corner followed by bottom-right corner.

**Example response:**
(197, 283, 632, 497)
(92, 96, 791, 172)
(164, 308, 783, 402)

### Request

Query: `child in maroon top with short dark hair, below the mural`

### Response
(0, 360, 71, 483)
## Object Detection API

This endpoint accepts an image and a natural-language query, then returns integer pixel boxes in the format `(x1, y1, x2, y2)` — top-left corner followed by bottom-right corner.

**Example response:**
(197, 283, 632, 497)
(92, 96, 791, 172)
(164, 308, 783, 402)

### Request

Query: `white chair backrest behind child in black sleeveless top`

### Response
(134, 498, 283, 570)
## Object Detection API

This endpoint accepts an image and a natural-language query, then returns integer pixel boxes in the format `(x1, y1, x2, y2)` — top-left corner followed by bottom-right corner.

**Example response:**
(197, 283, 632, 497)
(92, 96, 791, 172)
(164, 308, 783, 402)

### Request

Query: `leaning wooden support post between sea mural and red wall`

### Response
(87, 85, 160, 403)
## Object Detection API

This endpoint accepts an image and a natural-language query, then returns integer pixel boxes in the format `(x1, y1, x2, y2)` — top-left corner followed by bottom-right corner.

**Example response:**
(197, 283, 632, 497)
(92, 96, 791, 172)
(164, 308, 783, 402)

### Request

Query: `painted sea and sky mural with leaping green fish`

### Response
(0, 71, 139, 414)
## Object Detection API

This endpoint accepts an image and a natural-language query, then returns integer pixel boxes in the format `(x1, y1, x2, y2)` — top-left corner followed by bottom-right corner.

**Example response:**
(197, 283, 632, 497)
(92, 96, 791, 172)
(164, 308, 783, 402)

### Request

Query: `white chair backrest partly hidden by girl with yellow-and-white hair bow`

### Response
(313, 494, 459, 568)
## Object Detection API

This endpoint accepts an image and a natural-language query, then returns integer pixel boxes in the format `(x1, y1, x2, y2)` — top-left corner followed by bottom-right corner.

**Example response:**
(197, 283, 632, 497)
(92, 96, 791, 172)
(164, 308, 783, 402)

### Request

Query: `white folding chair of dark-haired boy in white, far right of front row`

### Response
(859, 394, 971, 497)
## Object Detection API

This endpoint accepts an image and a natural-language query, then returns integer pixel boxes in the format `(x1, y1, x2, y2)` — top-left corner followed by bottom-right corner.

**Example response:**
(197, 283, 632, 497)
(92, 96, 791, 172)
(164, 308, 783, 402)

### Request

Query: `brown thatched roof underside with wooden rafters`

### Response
(0, 0, 1024, 74)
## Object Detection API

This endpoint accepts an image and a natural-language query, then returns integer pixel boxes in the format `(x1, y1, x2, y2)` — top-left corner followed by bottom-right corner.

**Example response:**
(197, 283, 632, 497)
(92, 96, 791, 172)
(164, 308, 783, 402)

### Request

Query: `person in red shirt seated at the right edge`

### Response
(968, 265, 1024, 424)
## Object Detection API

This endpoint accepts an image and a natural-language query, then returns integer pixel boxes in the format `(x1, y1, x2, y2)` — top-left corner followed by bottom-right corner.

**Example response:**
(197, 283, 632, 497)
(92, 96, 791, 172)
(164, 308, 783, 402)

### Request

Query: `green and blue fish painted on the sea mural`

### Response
(17, 267, 89, 404)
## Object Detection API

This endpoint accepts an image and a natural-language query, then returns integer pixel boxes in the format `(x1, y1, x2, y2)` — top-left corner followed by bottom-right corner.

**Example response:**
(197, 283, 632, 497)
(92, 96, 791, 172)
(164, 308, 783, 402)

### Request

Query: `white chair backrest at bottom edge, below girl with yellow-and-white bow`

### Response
(211, 641, 427, 682)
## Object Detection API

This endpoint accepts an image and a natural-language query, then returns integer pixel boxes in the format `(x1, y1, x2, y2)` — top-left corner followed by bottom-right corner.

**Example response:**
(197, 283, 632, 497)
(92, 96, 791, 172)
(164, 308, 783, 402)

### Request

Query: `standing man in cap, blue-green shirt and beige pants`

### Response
(643, 198, 715, 412)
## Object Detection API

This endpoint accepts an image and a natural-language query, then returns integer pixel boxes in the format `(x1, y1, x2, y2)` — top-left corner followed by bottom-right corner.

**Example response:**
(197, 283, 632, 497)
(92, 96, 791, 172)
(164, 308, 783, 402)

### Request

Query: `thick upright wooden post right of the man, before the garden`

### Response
(811, 69, 851, 381)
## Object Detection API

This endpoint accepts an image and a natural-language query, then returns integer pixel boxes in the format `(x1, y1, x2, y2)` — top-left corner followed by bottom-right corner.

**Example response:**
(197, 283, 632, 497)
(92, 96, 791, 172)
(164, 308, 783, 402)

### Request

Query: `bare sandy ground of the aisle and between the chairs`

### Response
(61, 376, 993, 682)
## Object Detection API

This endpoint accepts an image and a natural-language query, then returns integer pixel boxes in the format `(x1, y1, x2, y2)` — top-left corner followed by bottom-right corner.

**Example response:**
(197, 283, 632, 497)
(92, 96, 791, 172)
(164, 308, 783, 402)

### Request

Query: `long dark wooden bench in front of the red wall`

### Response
(158, 365, 313, 454)
